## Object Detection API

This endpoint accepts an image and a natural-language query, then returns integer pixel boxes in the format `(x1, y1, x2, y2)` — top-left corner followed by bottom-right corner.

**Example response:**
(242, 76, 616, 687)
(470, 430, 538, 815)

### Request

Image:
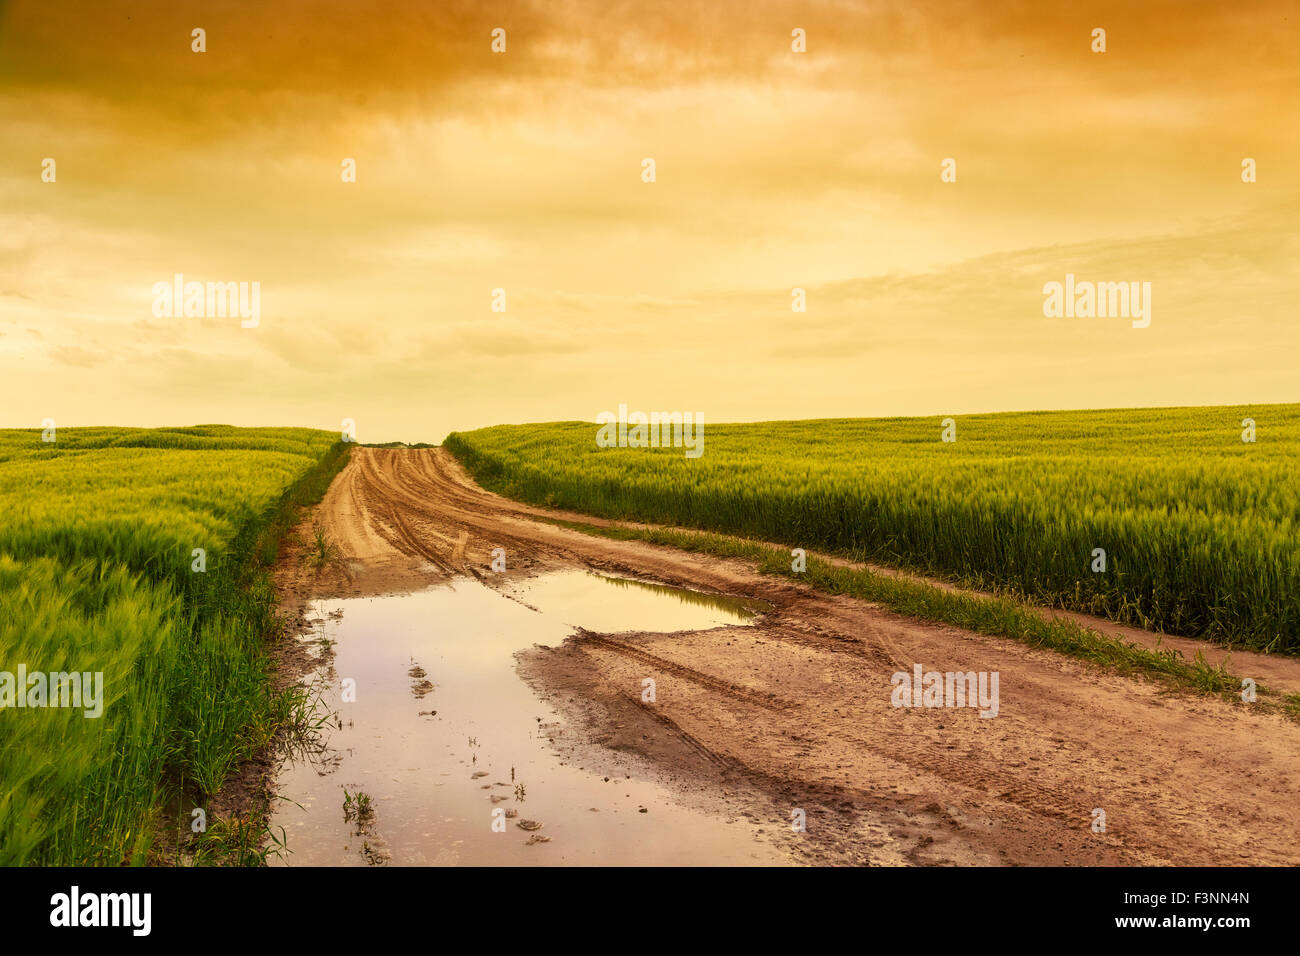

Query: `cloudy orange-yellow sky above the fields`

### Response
(0, 0, 1300, 442)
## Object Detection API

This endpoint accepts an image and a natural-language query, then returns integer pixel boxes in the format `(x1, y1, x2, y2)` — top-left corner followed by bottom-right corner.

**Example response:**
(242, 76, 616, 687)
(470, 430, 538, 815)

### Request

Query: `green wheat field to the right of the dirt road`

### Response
(445, 405, 1300, 653)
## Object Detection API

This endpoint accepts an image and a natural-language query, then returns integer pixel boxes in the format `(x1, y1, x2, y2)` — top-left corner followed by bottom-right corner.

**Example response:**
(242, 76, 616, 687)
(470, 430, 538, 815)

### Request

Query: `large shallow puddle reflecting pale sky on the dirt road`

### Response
(272, 572, 788, 866)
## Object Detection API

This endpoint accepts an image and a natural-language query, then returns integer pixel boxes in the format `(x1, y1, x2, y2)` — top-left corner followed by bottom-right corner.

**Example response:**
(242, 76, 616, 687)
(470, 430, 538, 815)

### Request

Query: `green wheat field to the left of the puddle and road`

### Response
(0, 425, 346, 865)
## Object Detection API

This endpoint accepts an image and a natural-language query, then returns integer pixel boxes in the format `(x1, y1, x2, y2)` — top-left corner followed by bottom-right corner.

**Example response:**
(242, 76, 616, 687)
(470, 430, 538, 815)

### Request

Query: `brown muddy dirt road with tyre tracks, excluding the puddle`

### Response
(282, 449, 1300, 865)
